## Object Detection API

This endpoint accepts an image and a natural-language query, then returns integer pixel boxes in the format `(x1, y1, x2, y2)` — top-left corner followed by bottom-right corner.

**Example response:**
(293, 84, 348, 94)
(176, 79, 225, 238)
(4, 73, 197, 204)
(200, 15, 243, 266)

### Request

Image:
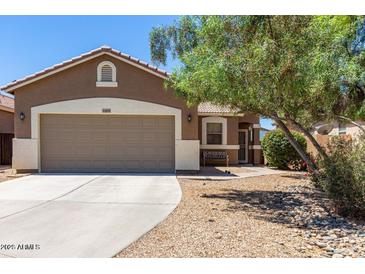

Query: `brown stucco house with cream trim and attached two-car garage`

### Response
(1, 46, 261, 172)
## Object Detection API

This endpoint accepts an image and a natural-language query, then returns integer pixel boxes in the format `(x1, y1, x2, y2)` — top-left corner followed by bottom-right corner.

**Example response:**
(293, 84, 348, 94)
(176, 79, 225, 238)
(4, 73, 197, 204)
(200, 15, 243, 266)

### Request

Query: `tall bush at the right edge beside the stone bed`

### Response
(316, 136, 365, 216)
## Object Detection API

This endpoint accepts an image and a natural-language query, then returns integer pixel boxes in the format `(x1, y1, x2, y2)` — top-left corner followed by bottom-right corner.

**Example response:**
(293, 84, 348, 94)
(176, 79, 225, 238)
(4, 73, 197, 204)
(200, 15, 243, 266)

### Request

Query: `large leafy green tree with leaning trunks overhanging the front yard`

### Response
(150, 16, 364, 173)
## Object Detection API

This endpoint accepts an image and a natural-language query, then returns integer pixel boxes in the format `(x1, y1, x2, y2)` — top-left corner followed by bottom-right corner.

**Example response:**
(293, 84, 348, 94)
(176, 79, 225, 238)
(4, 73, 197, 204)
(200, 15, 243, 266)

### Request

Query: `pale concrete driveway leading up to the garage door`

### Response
(0, 174, 181, 257)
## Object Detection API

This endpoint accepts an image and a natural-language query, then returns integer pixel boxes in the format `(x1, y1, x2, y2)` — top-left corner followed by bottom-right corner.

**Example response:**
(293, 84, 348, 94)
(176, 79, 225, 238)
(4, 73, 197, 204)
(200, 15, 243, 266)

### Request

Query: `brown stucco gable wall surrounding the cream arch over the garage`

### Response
(14, 55, 198, 140)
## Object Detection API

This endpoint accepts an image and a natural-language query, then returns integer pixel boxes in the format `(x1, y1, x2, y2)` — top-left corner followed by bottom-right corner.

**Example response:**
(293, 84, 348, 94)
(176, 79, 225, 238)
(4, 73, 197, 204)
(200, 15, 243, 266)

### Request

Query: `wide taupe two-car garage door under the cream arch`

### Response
(40, 114, 175, 172)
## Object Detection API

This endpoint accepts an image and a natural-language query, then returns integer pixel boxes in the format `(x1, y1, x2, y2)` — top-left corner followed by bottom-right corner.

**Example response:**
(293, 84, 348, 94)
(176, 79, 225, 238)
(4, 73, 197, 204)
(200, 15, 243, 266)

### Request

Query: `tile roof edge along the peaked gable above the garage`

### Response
(0, 46, 169, 90)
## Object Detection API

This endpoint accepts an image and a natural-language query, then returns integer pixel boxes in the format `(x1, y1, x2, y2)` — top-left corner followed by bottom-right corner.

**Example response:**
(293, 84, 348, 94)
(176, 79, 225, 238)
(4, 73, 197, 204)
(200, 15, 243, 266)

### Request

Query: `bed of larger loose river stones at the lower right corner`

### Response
(283, 183, 365, 258)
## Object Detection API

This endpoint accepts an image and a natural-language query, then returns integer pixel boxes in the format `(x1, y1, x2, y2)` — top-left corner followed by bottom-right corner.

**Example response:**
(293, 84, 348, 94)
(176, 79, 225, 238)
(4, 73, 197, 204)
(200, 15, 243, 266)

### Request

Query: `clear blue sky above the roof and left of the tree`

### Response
(0, 16, 271, 128)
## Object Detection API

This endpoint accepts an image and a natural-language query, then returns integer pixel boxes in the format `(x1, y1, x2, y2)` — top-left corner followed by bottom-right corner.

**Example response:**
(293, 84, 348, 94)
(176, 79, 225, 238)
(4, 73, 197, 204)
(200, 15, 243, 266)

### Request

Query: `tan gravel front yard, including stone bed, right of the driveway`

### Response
(116, 173, 365, 258)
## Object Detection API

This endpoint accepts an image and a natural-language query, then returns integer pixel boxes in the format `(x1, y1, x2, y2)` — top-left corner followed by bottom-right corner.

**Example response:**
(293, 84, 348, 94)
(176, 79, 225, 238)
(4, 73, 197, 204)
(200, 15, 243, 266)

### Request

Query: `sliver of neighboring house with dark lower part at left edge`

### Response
(0, 93, 14, 165)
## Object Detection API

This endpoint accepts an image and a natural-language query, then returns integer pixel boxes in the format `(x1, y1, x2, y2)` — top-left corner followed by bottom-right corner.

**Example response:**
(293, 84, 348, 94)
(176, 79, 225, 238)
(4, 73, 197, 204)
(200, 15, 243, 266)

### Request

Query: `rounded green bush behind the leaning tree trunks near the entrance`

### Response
(261, 130, 307, 169)
